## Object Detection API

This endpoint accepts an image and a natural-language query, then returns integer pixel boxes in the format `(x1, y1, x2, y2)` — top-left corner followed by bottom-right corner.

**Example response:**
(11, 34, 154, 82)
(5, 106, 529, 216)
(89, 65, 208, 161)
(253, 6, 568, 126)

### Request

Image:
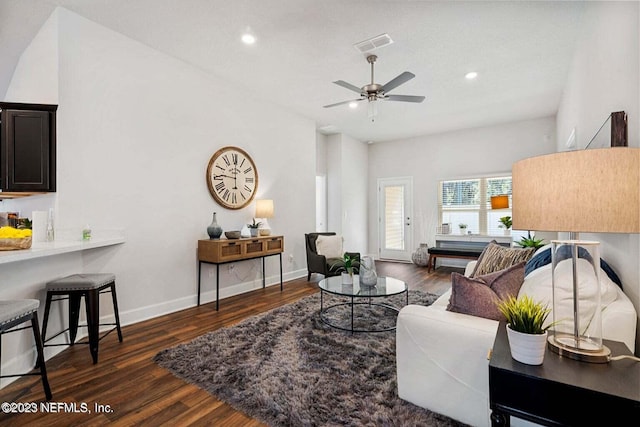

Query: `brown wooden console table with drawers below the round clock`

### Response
(198, 236, 284, 310)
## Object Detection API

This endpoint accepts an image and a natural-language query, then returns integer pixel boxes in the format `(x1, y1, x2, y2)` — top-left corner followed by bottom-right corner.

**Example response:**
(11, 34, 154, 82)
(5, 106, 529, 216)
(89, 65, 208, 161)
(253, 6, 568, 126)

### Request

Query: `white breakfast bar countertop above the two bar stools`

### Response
(0, 237, 125, 264)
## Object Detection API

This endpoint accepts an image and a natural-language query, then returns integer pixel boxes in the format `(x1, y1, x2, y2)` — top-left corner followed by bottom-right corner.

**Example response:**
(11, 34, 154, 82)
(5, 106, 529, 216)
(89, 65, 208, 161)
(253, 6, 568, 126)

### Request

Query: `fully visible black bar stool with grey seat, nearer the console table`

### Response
(42, 273, 122, 364)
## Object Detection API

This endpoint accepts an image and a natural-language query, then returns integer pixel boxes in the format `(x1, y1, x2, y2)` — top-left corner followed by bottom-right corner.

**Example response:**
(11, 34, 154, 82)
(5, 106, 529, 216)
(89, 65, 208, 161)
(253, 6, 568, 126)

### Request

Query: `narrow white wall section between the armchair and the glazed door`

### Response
(326, 134, 368, 254)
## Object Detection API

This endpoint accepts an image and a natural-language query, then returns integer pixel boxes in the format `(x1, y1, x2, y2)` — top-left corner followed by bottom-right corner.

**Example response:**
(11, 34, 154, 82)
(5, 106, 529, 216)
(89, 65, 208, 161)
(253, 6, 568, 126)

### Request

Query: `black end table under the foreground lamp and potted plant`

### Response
(489, 322, 640, 427)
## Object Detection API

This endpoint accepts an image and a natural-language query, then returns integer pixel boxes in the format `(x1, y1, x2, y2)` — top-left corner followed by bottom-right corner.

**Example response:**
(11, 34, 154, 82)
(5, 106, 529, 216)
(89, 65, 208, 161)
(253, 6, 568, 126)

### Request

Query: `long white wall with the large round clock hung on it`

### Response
(0, 9, 316, 382)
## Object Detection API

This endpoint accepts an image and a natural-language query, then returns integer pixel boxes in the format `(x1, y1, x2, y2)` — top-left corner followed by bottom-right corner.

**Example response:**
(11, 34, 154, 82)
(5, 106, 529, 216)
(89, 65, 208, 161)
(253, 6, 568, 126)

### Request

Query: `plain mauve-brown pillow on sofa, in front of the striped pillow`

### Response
(447, 262, 525, 320)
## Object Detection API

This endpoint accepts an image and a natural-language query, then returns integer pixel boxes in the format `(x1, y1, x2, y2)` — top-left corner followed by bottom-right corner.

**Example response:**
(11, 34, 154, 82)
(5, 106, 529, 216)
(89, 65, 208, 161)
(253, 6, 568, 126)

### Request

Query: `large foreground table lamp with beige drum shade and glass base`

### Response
(512, 147, 640, 363)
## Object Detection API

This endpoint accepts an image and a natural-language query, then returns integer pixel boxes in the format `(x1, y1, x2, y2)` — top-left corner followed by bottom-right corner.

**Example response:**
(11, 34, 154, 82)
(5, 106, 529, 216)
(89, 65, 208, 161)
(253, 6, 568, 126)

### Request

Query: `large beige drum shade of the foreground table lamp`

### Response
(512, 147, 640, 233)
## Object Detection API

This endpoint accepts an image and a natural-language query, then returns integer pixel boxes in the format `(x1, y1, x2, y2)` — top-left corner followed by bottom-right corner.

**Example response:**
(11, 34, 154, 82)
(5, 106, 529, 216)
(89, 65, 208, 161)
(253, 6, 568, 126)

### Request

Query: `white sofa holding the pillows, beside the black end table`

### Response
(396, 254, 637, 426)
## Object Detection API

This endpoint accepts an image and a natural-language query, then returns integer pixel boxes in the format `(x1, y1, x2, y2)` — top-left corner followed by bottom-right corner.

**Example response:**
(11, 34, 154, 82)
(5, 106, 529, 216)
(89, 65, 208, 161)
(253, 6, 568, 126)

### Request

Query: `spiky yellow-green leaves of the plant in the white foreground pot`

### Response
(498, 295, 552, 334)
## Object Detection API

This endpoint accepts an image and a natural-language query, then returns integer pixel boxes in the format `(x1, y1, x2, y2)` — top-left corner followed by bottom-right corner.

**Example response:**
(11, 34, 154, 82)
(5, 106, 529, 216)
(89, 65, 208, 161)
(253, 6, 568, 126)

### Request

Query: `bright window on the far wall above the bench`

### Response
(438, 176, 511, 235)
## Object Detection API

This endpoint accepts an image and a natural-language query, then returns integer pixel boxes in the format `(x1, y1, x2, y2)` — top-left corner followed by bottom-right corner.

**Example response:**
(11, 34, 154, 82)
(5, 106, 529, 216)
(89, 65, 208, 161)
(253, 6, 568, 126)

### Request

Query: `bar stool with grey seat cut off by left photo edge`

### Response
(0, 299, 51, 400)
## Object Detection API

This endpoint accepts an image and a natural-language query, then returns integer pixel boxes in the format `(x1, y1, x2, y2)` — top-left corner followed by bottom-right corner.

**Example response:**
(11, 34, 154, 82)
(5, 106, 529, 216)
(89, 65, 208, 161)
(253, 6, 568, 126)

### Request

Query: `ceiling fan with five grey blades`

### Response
(324, 55, 424, 121)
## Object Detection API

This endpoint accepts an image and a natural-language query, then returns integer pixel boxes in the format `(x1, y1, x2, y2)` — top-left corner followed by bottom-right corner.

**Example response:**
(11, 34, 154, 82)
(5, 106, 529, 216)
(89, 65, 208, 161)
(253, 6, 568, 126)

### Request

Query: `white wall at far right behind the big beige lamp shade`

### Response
(557, 2, 640, 354)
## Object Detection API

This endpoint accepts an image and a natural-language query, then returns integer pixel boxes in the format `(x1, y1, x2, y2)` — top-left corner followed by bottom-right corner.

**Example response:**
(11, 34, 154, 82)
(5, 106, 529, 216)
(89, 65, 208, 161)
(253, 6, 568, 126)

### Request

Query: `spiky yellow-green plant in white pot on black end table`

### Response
(498, 295, 553, 365)
